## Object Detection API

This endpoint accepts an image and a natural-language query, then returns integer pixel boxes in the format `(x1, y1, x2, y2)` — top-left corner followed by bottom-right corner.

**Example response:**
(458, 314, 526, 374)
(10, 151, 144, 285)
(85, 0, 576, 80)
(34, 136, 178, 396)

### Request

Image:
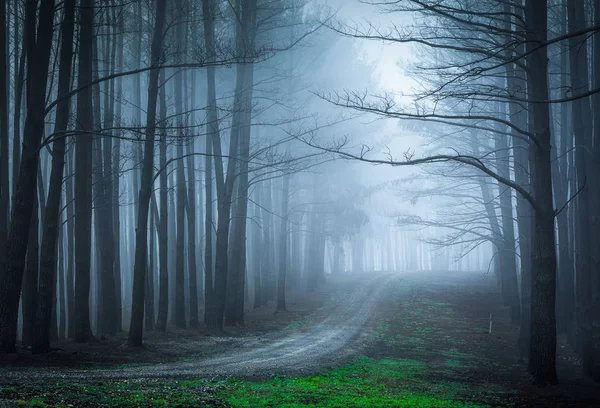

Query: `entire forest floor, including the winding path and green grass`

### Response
(0, 272, 600, 407)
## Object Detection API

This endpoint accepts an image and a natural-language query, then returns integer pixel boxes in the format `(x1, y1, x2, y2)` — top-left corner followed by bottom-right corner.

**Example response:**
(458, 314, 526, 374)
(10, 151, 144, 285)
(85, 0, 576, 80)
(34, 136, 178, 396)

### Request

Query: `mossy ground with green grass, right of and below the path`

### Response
(0, 275, 600, 408)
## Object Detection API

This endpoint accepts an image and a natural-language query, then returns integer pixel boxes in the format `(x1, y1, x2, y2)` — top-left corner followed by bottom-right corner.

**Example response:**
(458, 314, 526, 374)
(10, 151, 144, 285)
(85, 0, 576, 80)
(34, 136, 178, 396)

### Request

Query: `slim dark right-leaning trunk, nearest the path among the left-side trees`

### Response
(128, 0, 167, 347)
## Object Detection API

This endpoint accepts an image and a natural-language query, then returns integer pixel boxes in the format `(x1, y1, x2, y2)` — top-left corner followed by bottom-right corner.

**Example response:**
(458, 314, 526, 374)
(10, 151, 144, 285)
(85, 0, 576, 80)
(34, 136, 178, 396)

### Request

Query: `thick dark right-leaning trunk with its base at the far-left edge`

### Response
(0, 0, 55, 355)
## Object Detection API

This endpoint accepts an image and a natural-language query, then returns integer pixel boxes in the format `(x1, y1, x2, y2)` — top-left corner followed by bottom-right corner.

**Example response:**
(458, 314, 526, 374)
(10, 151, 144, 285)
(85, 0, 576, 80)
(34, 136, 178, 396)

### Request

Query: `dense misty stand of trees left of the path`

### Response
(0, 0, 376, 355)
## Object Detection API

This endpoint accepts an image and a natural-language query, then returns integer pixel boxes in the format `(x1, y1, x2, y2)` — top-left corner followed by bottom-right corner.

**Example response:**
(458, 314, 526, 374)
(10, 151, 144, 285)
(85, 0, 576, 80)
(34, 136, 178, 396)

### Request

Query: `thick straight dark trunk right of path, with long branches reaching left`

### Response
(525, 0, 558, 385)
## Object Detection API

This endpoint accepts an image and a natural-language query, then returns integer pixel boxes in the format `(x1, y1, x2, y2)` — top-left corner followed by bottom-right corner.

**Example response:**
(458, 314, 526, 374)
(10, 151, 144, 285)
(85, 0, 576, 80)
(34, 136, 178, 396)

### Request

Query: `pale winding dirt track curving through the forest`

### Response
(0, 274, 399, 383)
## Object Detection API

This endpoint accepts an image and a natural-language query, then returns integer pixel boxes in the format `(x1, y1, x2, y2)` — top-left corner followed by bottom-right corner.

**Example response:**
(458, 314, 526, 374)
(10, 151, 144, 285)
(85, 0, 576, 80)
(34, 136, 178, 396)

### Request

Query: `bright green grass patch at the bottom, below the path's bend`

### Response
(219, 357, 489, 408)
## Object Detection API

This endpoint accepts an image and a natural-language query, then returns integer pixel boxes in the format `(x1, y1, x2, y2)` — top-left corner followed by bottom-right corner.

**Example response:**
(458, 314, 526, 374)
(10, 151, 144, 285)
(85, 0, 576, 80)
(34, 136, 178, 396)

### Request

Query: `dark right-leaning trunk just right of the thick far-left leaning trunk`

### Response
(32, 0, 75, 353)
